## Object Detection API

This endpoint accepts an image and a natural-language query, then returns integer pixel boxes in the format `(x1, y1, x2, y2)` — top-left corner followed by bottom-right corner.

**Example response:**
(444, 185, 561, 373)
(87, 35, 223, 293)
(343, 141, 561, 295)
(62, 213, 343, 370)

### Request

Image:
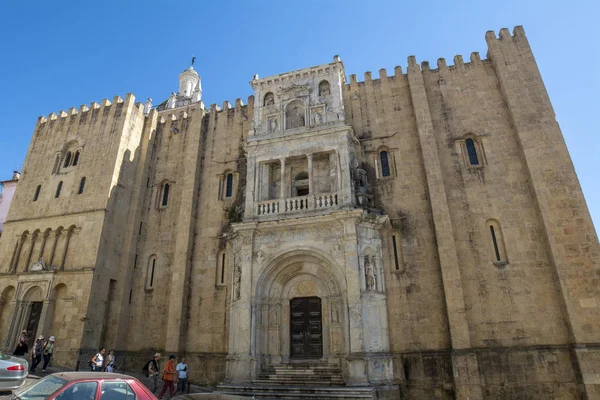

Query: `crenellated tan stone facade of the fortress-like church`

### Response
(0, 27, 600, 399)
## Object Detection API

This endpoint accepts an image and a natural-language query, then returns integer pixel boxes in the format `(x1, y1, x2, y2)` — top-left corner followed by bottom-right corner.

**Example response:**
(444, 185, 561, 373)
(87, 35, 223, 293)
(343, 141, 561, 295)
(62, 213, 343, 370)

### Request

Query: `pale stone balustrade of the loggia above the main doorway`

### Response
(257, 193, 338, 216)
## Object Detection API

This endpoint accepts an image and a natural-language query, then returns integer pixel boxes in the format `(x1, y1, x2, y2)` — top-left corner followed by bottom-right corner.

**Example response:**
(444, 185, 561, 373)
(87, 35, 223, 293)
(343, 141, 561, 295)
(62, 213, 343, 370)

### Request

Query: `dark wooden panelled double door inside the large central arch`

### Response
(290, 297, 323, 359)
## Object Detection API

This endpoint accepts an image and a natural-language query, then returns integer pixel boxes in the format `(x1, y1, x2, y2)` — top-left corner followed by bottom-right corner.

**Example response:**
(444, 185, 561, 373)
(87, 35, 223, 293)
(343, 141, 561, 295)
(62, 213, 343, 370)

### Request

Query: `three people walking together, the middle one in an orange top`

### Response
(142, 353, 188, 399)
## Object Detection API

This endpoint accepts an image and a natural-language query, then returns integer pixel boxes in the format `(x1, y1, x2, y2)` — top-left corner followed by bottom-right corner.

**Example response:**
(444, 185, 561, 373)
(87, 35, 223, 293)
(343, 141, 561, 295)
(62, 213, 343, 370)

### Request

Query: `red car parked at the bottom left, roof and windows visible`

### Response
(12, 372, 156, 400)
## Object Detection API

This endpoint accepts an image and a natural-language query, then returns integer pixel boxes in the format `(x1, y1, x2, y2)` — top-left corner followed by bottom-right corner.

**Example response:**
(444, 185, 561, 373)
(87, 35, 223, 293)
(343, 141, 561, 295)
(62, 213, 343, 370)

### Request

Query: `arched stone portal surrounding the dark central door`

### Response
(254, 250, 348, 366)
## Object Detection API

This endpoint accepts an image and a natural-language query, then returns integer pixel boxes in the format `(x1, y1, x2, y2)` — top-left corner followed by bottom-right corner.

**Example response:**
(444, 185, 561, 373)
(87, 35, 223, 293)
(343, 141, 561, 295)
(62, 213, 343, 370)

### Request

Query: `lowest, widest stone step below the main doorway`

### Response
(217, 384, 375, 400)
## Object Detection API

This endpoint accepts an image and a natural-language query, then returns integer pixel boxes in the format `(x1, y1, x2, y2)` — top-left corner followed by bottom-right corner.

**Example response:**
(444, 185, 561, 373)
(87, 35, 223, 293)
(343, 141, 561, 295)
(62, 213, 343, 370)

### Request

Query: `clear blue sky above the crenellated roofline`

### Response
(0, 0, 600, 233)
